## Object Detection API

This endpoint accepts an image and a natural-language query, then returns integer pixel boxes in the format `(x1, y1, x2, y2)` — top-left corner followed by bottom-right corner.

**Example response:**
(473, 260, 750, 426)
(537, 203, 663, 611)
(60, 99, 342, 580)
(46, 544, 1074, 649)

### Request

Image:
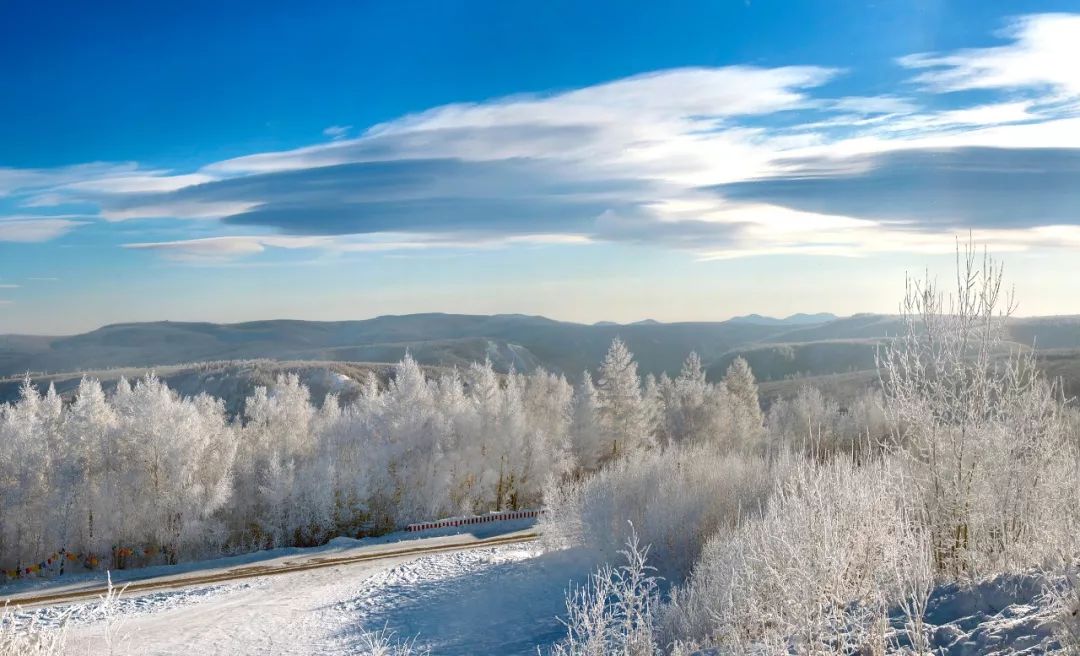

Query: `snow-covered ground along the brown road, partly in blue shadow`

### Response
(4, 527, 589, 656)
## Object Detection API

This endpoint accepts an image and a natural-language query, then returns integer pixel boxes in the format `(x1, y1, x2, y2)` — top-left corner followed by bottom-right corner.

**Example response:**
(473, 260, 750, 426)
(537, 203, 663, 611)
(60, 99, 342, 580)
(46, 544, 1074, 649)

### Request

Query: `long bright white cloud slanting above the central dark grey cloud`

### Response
(204, 66, 838, 175)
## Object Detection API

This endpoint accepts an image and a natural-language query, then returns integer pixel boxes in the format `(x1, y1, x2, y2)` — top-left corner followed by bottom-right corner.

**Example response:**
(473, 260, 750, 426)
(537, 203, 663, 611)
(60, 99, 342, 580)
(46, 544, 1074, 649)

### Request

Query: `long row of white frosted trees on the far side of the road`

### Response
(0, 339, 762, 571)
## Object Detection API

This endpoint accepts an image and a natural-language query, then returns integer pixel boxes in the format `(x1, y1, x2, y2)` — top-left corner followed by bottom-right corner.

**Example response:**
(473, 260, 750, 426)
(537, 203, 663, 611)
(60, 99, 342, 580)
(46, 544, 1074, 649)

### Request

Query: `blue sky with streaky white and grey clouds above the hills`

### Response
(0, 1, 1080, 333)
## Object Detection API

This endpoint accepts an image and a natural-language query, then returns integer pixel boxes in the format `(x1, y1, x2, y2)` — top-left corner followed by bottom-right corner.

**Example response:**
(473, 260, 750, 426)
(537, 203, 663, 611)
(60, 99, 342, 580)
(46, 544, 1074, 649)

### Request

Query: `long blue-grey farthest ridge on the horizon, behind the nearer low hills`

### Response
(0, 313, 803, 376)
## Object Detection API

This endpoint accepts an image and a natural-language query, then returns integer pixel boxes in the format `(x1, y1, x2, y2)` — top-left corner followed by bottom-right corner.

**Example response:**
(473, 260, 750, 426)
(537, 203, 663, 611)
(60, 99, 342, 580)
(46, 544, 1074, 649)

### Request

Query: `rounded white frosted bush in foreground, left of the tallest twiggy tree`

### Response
(664, 459, 926, 653)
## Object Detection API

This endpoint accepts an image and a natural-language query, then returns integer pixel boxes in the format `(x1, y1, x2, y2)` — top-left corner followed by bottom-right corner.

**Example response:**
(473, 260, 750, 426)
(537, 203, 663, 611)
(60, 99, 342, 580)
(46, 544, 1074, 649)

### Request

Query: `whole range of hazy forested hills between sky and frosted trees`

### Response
(0, 313, 1080, 408)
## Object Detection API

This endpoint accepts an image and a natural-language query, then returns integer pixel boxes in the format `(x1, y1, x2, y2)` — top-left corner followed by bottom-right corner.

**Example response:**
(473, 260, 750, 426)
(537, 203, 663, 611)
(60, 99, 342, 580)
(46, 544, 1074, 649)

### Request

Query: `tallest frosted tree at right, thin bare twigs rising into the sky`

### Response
(879, 244, 1075, 575)
